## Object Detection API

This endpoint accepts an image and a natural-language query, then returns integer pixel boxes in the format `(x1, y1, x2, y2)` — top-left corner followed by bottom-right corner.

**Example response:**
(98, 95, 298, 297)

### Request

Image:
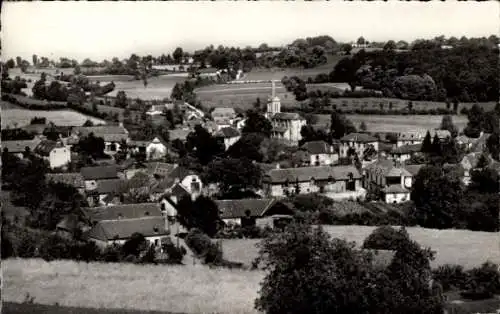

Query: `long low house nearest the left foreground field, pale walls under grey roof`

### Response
(87, 217, 170, 247)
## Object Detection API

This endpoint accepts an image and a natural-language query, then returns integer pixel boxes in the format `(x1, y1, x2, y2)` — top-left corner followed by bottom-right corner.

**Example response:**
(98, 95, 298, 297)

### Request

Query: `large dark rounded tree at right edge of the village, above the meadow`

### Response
(411, 166, 463, 228)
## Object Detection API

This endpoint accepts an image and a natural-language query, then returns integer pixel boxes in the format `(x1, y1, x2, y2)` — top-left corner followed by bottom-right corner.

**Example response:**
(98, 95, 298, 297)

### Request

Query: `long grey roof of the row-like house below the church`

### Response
(264, 165, 361, 183)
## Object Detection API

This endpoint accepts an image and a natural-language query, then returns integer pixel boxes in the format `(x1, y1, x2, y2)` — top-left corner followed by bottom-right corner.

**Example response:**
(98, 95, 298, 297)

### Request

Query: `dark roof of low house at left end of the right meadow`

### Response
(215, 198, 293, 219)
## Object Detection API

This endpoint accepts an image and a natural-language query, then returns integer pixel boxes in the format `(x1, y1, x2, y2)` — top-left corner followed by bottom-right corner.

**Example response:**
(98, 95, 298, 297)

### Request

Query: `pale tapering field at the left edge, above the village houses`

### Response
(2, 107, 106, 128)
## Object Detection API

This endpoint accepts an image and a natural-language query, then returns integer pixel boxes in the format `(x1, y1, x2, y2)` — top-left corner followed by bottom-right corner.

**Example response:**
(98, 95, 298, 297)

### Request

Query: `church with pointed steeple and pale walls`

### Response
(266, 81, 307, 145)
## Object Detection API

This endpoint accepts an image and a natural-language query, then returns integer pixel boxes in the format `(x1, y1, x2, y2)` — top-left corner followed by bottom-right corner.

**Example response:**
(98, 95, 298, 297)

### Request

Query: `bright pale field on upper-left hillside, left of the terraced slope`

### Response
(103, 75, 187, 100)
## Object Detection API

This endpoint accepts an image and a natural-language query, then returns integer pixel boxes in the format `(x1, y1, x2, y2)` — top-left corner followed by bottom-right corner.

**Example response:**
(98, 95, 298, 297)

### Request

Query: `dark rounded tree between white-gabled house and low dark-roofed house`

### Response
(177, 196, 221, 237)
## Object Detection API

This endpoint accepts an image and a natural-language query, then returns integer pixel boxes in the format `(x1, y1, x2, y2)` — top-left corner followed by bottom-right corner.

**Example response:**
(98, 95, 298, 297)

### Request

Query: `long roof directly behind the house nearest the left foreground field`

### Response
(82, 203, 162, 221)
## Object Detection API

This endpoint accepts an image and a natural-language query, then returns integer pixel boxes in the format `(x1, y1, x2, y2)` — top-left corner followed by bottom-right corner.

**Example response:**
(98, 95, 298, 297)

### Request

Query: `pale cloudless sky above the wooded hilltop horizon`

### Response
(1, 1, 500, 62)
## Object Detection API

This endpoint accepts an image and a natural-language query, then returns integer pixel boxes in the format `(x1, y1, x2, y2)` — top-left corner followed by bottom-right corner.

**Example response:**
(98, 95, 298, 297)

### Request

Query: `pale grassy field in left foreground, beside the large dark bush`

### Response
(2, 259, 263, 314)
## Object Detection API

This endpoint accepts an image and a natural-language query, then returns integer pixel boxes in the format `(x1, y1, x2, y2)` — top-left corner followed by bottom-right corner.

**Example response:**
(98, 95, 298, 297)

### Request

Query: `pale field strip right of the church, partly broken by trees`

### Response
(316, 114, 467, 132)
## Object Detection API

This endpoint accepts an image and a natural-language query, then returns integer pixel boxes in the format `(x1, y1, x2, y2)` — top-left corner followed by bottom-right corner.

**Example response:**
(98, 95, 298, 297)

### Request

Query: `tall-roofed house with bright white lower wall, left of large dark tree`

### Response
(364, 159, 413, 203)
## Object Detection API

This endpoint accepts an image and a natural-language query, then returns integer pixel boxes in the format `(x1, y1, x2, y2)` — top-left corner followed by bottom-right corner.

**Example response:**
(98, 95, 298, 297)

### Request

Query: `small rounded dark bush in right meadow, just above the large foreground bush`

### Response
(363, 226, 410, 250)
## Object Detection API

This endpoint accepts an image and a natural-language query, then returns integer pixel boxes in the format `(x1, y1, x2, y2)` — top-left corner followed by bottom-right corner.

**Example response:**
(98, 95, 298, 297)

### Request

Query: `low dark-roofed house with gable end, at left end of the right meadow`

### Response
(215, 198, 294, 227)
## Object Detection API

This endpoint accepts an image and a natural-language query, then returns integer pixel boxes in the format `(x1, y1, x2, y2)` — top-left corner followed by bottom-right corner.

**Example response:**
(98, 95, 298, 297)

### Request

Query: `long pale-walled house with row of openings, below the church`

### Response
(262, 165, 366, 199)
